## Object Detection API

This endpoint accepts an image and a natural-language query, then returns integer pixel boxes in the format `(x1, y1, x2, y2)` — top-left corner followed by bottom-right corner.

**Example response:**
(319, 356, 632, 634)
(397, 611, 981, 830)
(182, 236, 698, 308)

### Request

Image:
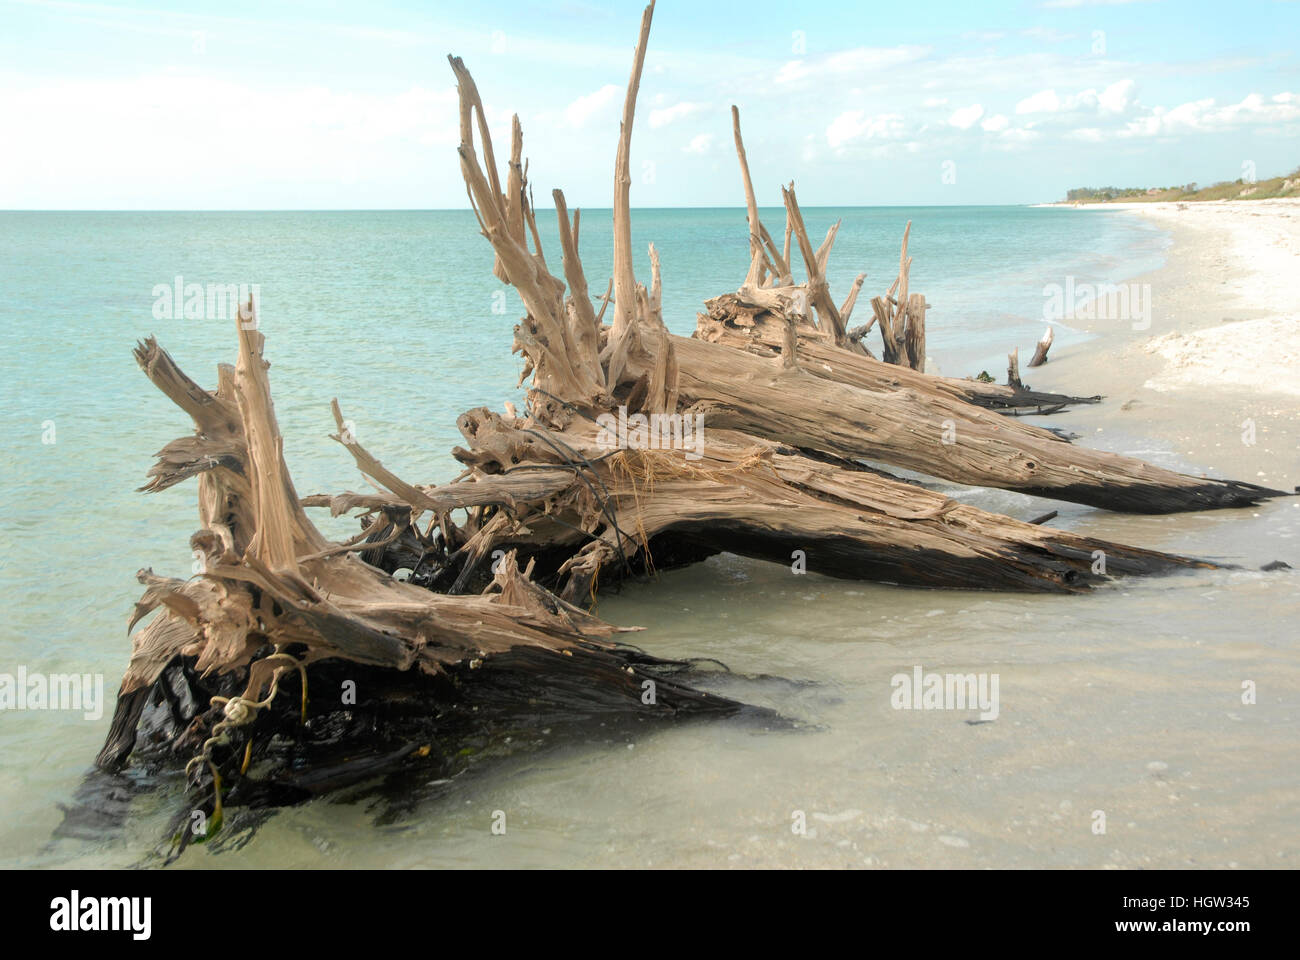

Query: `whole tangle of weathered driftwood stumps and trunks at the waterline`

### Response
(99, 3, 1289, 842)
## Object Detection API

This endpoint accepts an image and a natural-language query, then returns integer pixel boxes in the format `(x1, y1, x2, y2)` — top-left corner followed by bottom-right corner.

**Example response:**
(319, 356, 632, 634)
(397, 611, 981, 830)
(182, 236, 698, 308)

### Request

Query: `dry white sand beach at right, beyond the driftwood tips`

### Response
(1022, 200, 1300, 489)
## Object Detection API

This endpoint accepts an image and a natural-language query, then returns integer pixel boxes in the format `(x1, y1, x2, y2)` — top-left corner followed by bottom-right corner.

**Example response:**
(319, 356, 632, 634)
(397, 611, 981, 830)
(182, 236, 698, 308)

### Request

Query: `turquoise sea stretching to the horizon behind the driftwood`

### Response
(0, 207, 1190, 865)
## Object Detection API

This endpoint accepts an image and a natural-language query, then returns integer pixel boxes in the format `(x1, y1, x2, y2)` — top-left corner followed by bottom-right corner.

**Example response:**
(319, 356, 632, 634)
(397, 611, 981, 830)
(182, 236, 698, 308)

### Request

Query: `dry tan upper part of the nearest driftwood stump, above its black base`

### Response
(124, 324, 644, 699)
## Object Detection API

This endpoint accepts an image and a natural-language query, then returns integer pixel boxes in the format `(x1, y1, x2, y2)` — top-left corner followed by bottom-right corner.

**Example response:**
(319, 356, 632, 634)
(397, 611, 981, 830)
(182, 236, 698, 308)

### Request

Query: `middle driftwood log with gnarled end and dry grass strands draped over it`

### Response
(332, 410, 1210, 601)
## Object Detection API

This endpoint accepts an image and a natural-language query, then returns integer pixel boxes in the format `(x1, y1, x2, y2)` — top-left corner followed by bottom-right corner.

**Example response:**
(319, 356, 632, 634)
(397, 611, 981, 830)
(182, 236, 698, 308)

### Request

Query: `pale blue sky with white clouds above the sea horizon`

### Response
(0, 0, 1300, 209)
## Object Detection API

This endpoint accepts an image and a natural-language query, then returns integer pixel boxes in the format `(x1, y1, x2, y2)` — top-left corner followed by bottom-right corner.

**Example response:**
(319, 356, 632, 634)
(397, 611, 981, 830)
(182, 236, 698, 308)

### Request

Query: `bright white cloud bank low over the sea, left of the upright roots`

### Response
(0, 73, 462, 207)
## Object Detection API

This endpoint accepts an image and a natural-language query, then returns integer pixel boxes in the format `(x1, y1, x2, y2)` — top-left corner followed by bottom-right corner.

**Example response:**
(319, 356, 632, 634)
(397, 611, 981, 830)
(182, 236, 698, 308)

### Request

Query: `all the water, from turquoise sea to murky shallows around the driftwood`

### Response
(0, 208, 1300, 868)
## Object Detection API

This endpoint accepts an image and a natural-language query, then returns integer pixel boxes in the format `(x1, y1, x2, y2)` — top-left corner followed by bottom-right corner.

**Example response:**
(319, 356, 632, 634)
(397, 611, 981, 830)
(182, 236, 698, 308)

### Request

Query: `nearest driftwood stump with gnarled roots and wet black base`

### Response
(98, 324, 741, 844)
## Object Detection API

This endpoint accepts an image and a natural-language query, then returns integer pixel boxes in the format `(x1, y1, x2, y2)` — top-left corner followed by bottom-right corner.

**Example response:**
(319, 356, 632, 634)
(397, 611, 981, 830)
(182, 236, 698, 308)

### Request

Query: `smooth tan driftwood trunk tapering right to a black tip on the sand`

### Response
(629, 338, 1284, 514)
